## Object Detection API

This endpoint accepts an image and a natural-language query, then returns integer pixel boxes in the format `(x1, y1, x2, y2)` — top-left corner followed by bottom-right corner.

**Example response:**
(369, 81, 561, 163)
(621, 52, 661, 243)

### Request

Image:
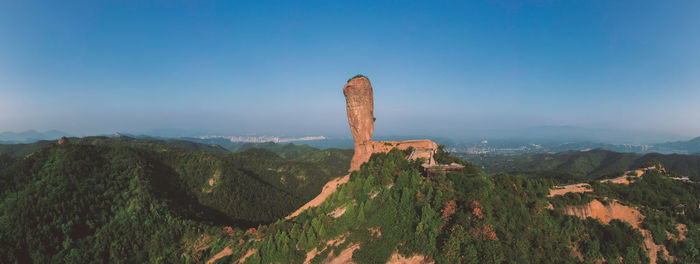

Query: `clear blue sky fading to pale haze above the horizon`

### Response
(0, 0, 700, 142)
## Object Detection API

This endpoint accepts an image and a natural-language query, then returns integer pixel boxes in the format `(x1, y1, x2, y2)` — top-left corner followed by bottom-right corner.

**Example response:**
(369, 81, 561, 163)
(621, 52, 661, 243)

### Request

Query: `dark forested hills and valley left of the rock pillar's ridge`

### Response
(0, 137, 349, 263)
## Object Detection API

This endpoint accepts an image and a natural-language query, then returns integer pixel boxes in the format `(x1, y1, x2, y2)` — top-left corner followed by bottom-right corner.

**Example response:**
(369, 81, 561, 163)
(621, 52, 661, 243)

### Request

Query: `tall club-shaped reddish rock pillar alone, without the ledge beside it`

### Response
(343, 77, 374, 171)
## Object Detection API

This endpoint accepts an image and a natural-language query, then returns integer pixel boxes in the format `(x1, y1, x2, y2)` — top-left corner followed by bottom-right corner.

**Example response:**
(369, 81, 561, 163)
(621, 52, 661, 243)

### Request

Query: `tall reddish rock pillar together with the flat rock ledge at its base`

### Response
(343, 75, 437, 171)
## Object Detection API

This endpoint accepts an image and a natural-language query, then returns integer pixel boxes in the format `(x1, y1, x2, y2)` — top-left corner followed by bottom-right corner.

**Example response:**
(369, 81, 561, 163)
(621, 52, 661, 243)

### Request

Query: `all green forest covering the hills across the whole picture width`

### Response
(0, 137, 700, 263)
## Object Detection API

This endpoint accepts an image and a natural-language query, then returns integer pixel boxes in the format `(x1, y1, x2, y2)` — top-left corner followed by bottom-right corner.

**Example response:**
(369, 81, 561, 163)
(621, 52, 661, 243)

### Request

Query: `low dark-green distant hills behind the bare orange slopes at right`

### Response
(464, 149, 700, 182)
